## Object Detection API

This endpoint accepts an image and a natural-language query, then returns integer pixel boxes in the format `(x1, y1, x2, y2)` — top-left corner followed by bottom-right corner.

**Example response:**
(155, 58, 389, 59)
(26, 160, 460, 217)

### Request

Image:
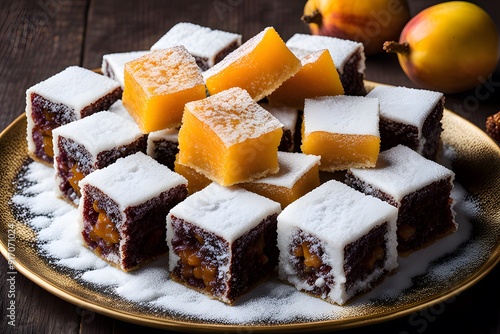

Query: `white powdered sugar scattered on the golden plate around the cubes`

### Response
(11, 154, 482, 324)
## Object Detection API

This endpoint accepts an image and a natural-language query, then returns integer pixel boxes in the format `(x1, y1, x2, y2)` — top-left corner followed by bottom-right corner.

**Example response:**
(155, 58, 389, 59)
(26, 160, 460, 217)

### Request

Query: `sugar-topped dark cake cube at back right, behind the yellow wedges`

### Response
(286, 34, 366, 96)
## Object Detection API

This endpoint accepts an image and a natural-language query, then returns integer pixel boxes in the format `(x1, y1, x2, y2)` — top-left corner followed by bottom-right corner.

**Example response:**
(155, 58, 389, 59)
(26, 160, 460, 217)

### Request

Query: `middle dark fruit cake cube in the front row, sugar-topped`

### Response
(167, 183, 281, 304)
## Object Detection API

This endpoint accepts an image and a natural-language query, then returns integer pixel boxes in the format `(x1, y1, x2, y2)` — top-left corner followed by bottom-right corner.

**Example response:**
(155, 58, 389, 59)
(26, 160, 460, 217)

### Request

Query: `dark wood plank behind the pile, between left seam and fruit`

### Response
(83, 0, 308, 68)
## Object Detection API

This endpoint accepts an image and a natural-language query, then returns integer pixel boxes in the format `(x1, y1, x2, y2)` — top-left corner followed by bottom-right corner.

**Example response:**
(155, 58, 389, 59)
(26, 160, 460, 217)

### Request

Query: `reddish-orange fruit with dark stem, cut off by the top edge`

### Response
(302, 0, 410, 55)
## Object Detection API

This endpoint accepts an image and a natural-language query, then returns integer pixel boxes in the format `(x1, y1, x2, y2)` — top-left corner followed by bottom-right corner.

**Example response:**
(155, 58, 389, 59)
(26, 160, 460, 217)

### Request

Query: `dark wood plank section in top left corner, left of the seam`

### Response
(0, 0, 87, 129)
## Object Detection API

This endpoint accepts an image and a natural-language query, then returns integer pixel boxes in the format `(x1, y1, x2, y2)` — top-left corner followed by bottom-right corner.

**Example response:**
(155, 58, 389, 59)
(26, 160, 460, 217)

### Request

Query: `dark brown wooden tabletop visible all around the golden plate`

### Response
(0, 0, 500, 334)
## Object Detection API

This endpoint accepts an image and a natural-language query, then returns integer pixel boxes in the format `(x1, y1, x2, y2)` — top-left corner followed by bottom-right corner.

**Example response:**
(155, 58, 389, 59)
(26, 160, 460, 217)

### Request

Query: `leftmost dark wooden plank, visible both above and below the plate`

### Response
(0, 0, 87, 333)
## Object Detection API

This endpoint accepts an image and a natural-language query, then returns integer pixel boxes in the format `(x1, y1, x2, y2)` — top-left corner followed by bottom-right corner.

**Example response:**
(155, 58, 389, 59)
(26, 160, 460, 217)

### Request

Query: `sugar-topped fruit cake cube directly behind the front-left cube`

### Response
(53, 111, 147, 205)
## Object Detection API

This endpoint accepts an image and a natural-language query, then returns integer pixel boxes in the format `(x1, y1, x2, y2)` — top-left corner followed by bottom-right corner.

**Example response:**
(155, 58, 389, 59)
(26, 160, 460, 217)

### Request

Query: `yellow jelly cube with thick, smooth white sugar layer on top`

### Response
(301, 95, 380, 171)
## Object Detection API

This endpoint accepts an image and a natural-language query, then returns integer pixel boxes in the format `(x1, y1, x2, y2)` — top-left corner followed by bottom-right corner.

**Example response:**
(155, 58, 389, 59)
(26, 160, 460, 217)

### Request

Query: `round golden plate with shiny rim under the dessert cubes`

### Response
(0, 83, 500, 332)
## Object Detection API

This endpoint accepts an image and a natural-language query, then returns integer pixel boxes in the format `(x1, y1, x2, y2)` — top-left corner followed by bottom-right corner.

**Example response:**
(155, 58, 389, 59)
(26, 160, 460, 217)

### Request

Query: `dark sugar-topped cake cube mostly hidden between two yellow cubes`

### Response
(260, 103, 300, 152)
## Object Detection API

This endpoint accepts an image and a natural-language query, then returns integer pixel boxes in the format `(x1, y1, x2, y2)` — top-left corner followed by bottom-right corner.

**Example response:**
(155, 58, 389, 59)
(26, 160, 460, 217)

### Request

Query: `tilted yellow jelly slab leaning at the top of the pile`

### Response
(203, 27, 301, 101)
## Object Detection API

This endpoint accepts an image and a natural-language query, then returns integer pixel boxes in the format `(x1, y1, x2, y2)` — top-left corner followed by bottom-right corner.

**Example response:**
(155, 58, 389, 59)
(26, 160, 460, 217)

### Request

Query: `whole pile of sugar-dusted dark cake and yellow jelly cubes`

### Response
(26, 23, 457, 304)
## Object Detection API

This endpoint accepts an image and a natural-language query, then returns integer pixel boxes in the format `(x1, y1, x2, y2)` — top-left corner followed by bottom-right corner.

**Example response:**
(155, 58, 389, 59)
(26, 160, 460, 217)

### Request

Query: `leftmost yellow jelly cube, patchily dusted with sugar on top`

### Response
(122, 46, 206, 133)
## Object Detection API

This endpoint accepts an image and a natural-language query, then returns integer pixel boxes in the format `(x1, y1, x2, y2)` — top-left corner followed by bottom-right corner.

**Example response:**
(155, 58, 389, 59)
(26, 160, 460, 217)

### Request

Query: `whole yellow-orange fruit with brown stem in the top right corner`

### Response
(384, 1, 499, 93)
